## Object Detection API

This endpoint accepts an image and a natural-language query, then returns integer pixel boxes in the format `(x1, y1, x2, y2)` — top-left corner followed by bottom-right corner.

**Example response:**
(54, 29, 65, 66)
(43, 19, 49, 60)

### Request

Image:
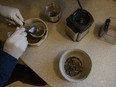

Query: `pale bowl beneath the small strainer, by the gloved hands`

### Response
(24, 18, 48, 46)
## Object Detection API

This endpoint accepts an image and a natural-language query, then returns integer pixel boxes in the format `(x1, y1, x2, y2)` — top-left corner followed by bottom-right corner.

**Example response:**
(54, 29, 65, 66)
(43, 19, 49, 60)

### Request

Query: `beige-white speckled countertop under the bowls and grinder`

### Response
(0, 0, 116, 87)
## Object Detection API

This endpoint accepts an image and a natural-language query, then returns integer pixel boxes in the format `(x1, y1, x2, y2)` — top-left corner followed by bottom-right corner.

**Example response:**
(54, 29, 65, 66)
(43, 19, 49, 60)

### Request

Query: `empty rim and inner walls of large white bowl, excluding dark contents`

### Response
(59, 49, 92, 82)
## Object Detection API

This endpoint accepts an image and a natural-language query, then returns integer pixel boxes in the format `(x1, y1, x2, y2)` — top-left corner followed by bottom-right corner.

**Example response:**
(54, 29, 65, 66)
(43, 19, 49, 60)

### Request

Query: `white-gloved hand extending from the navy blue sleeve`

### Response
(3, 28, 28, 59)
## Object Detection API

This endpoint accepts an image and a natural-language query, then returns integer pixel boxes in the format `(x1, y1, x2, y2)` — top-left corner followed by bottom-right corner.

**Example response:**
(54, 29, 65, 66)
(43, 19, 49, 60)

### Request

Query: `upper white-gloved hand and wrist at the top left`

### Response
(0, 5, 24, 25)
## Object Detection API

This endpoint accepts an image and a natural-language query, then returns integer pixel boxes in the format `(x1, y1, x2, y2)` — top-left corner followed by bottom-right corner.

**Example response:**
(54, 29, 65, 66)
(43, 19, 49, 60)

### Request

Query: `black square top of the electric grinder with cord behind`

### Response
(66, 9, 93, 33)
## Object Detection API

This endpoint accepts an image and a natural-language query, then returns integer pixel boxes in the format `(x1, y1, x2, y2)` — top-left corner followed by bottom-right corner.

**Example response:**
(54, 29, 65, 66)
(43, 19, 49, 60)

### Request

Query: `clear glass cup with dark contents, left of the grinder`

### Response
(45, 2, 61, 23)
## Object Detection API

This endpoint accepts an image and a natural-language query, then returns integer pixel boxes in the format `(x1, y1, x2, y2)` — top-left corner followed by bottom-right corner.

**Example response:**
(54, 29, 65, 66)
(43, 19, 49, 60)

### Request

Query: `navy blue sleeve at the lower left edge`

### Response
(0, 41, 17, 87)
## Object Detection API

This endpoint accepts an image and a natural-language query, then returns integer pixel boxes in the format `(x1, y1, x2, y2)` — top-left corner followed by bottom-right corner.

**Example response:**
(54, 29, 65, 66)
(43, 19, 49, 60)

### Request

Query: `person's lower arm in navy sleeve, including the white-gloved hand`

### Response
(0, 28, 28, 87)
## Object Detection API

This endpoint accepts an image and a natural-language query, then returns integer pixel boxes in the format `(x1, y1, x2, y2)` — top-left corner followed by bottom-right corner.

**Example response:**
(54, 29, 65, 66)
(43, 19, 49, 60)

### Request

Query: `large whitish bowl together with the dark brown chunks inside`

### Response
(59, 49, 92, 82)
